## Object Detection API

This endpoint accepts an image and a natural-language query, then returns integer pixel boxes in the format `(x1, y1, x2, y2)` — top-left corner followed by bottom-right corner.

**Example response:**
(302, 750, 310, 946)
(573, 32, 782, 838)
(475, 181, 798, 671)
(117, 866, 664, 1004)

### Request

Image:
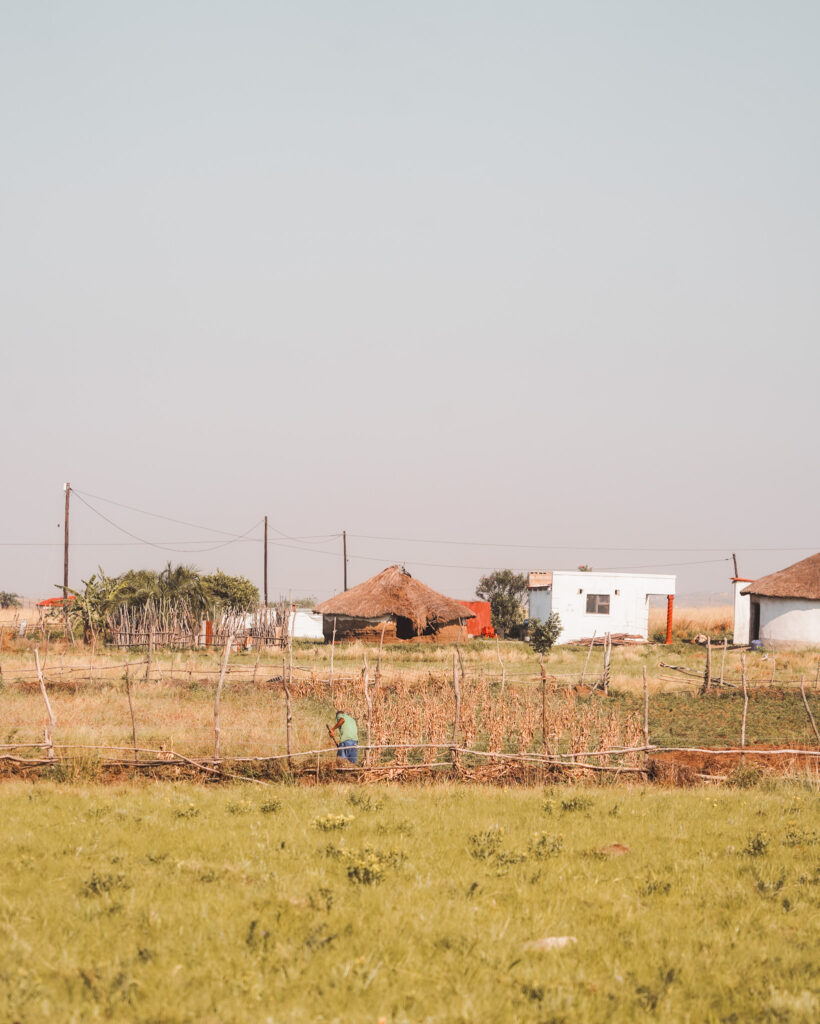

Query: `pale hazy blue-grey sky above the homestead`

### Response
(0, 0, 820, 599)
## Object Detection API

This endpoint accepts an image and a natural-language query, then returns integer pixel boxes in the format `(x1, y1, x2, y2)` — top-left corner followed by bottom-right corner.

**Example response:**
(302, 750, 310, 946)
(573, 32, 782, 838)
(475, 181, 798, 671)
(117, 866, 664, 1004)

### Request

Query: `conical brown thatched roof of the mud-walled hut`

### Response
(315, 565, 475, 633)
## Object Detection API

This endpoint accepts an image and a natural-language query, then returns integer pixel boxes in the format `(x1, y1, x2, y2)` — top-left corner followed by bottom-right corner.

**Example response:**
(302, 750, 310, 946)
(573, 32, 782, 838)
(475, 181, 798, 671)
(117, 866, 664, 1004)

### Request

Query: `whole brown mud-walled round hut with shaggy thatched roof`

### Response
(315, 565, 475, 641)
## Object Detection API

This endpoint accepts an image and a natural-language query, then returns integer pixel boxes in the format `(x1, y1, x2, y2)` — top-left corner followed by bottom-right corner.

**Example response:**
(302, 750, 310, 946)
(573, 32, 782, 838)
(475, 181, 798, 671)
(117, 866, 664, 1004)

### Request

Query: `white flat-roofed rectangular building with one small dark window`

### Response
(527, 570, 676, 643)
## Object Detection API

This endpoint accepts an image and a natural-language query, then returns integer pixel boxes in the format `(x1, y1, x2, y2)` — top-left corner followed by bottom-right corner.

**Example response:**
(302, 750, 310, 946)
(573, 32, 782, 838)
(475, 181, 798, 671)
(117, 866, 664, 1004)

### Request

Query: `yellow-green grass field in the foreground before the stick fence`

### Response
(0, 780, 820, 1024)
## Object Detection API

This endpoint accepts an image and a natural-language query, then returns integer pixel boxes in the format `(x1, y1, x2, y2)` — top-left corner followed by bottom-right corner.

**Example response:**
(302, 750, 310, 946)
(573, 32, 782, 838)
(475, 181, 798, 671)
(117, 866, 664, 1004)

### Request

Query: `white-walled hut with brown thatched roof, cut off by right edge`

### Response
(734, 553, 820, 647)
